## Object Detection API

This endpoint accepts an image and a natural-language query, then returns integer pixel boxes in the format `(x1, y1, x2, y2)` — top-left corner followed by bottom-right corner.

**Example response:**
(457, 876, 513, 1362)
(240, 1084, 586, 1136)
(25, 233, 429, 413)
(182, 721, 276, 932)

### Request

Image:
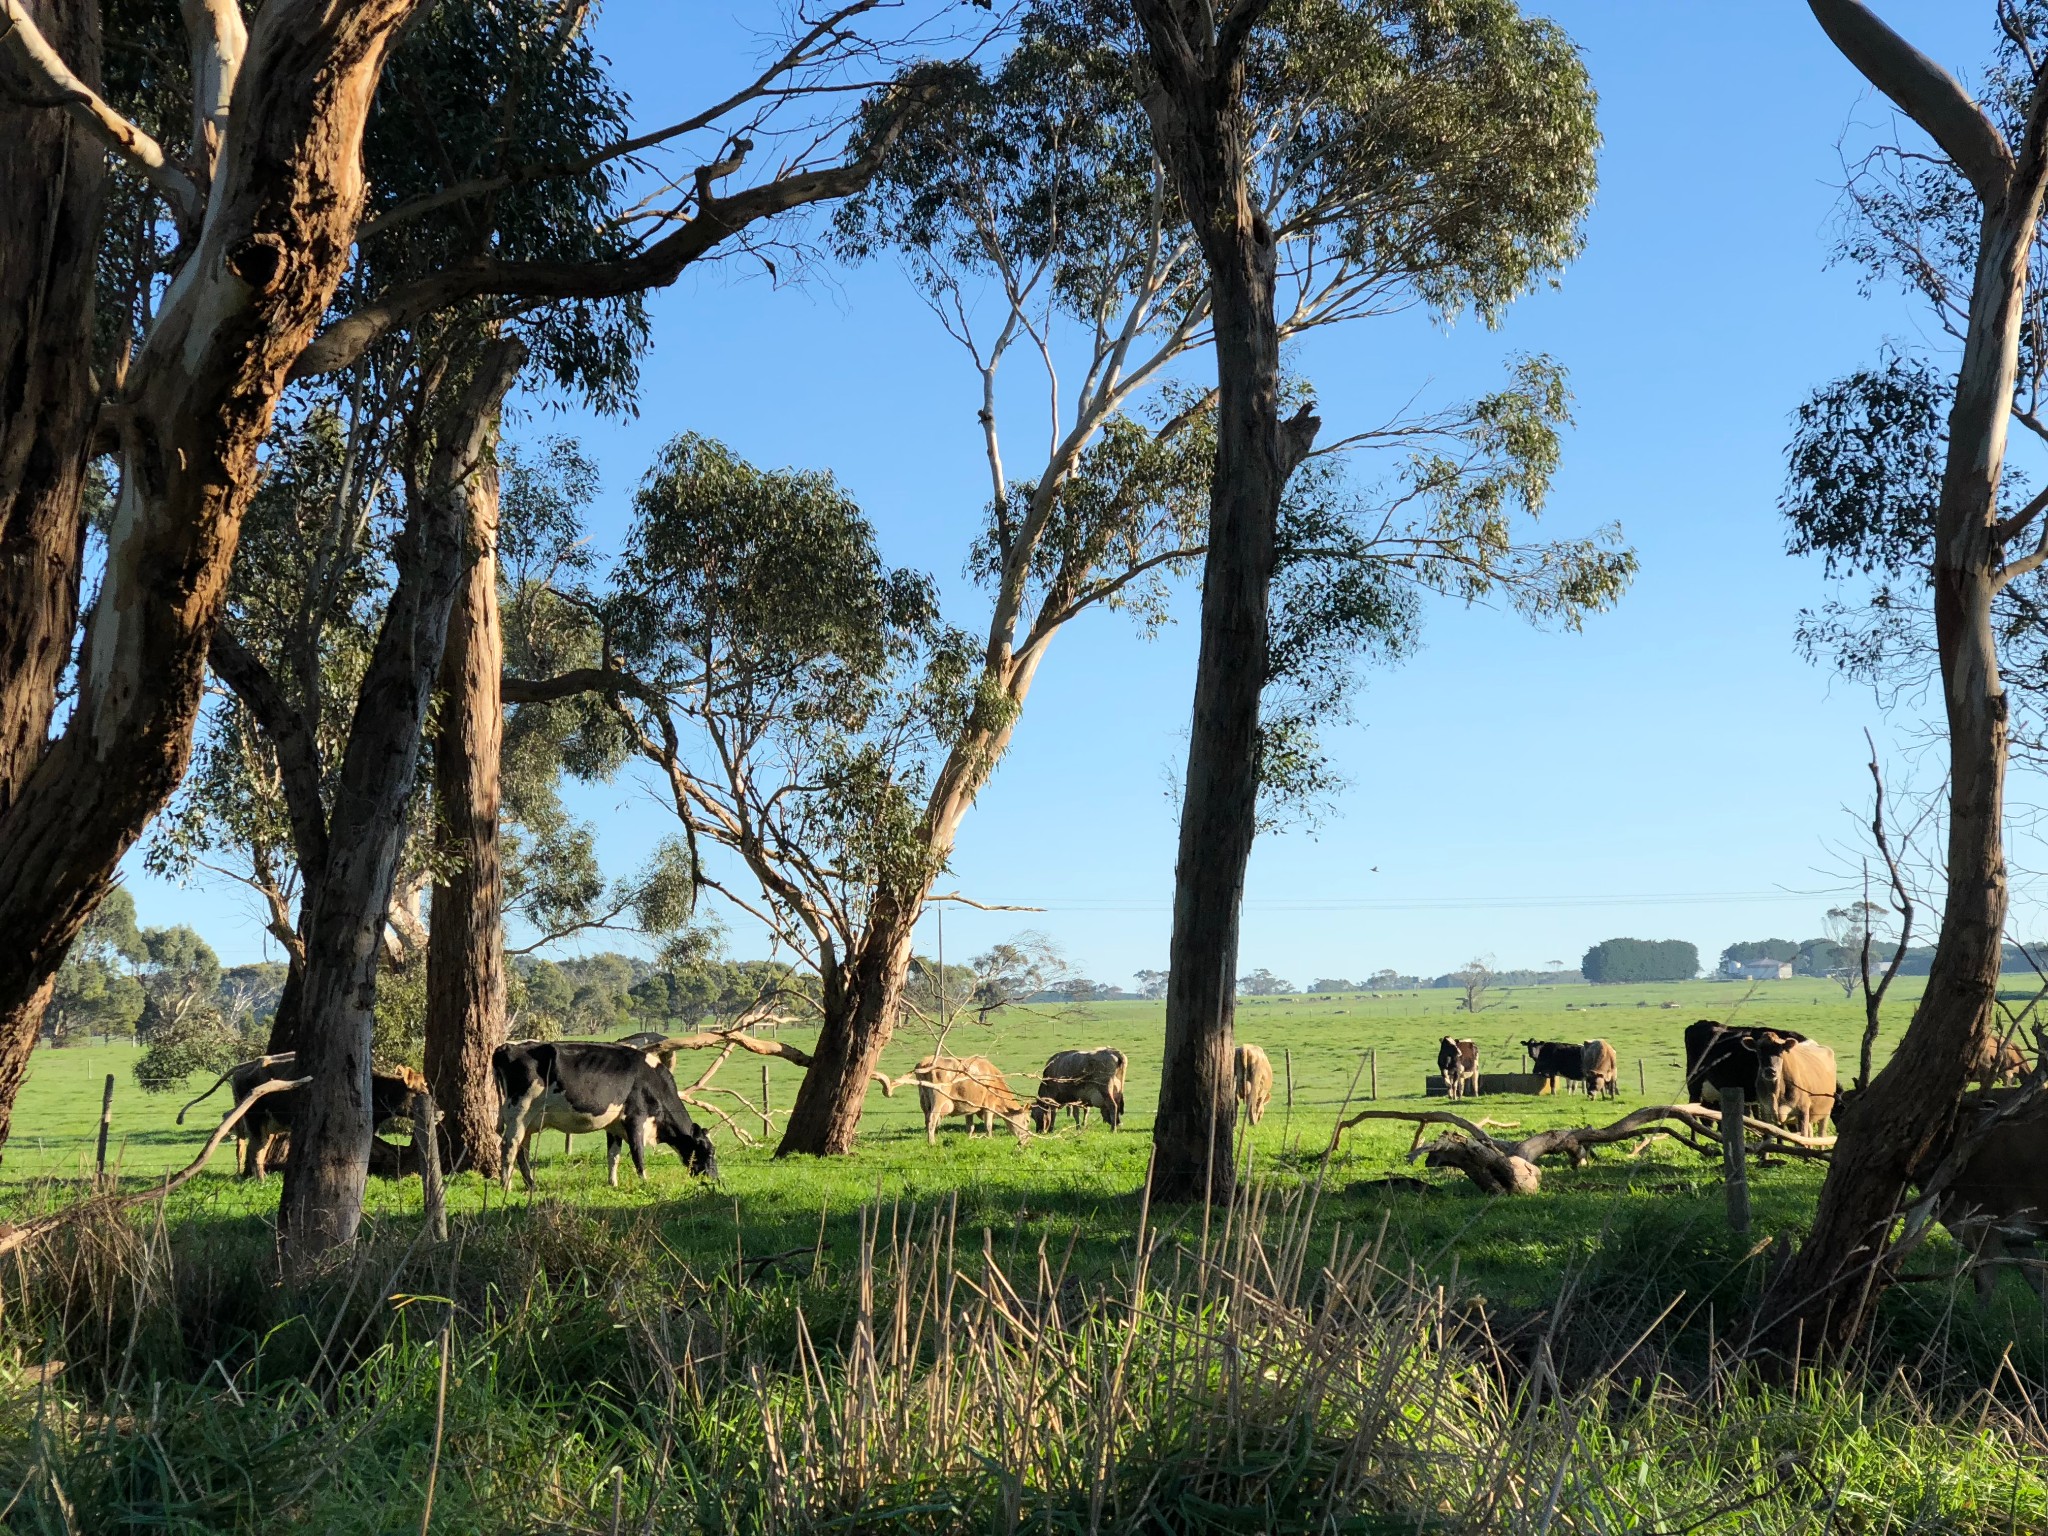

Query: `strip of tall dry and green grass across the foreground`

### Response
(0, 1182, 2048, 1536)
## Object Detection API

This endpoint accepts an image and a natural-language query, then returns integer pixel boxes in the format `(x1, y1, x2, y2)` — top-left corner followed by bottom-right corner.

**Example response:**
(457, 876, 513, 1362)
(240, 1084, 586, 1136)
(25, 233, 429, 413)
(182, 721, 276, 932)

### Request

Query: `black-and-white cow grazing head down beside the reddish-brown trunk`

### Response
(492, 1040, 719, 1190)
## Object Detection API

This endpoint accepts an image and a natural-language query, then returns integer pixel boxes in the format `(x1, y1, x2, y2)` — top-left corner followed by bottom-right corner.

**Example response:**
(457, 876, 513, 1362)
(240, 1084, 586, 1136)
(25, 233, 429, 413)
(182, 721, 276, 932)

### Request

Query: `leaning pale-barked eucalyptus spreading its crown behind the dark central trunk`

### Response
(765, 0, 1628, 1153)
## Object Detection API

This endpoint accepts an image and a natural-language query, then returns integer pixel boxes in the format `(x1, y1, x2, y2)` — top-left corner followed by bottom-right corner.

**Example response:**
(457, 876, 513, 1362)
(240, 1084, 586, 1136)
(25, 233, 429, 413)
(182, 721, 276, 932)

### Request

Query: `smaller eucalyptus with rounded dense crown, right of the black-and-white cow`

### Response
(604, 436, 975, 1151)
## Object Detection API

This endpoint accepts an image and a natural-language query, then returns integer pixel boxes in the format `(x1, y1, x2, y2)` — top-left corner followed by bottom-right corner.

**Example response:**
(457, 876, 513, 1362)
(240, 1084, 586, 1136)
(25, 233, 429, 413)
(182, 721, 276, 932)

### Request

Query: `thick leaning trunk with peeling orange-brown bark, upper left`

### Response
(0, 0, 418, 1143)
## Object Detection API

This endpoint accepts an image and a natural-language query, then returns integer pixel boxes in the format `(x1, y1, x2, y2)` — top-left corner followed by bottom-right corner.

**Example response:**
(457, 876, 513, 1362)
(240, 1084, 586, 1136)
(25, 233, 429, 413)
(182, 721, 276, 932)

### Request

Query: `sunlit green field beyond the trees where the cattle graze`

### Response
(0, 979, 1949, 1309)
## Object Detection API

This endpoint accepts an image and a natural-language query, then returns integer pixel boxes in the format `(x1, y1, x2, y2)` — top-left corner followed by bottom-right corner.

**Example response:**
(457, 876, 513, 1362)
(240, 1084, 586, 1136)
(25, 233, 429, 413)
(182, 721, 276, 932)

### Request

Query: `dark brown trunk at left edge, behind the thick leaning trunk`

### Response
(0, 0, 106, 815)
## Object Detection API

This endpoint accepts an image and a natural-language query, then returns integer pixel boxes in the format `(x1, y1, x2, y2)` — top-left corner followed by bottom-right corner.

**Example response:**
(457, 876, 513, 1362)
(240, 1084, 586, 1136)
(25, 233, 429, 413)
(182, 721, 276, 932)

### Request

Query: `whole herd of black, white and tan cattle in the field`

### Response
(178, 1020, 2048, 1288)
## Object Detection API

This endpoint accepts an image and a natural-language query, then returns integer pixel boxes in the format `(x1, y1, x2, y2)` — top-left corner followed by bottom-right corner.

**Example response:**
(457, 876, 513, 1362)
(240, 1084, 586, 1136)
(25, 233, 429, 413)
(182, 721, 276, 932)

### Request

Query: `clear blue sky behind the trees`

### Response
(129, 0, 2038, 983)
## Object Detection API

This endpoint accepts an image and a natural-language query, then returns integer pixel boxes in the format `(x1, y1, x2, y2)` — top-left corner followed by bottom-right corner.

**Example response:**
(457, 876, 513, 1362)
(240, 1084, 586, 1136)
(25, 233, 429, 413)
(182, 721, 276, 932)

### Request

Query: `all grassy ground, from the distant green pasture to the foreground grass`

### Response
(0, 981, 2048, 1536)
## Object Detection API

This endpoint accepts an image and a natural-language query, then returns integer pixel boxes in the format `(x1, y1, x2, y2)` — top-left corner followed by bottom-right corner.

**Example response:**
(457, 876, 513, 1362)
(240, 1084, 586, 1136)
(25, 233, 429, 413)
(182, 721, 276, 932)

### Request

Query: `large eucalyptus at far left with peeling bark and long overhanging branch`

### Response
(0, 0, 950, 1163)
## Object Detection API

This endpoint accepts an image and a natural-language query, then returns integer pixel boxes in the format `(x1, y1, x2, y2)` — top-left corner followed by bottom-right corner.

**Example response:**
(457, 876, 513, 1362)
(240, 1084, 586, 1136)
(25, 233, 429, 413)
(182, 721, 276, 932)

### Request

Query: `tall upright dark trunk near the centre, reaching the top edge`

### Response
(1137, 0, 1317, 1202)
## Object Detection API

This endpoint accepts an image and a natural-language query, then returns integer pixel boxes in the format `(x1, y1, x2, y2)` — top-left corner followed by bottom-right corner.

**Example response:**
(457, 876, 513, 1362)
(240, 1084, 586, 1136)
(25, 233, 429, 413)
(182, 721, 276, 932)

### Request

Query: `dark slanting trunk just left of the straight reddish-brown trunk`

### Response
(279, 342, 524, 1264)
